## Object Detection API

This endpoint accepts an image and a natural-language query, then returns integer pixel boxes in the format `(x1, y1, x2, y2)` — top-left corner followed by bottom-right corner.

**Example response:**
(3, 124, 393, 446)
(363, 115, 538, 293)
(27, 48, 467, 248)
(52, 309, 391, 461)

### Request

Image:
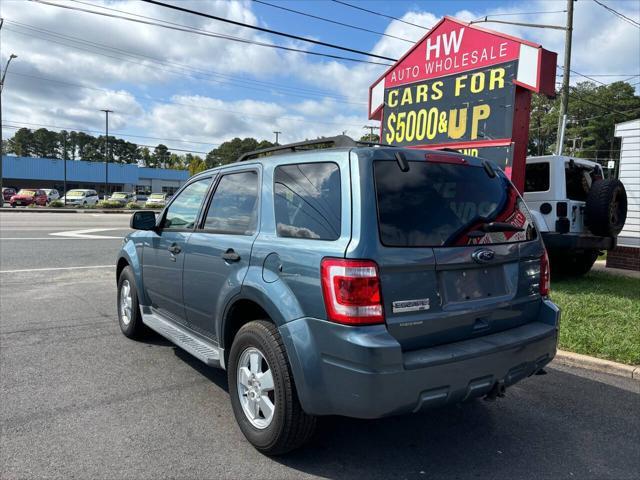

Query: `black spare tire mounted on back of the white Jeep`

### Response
(585, 179, 627, 236)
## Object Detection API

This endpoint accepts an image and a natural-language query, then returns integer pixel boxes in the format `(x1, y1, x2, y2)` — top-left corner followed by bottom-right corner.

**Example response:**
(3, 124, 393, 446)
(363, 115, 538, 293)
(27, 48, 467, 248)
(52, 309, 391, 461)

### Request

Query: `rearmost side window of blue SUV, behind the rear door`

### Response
(274, 162, 342, 240)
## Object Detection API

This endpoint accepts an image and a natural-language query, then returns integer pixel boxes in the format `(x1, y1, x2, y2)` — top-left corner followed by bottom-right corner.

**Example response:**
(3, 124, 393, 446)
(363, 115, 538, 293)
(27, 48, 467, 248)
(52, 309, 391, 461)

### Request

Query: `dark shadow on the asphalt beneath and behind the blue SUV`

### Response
(166, 334, 640, 479)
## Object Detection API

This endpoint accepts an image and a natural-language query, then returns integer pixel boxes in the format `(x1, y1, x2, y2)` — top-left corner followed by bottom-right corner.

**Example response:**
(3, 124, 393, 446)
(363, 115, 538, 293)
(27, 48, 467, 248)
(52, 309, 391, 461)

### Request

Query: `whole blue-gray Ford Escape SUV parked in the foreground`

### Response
(117, 137, 560, 454)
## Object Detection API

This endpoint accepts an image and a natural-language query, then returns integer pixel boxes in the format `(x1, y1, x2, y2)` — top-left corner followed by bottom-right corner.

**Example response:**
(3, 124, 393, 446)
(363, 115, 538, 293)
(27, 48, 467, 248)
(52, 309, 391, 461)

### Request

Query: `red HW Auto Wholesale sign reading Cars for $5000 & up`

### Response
(369, 17, 556, 189)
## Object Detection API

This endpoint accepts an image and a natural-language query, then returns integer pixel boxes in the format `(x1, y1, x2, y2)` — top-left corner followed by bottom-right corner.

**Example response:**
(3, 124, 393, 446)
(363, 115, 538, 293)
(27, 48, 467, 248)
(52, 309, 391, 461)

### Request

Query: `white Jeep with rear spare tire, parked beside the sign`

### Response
(524, 155, 627, 275)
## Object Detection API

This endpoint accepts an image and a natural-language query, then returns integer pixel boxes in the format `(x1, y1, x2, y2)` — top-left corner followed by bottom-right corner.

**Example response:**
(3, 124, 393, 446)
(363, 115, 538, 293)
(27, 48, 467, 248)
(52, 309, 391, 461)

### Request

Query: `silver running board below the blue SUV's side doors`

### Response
(142, 313, 225, 368)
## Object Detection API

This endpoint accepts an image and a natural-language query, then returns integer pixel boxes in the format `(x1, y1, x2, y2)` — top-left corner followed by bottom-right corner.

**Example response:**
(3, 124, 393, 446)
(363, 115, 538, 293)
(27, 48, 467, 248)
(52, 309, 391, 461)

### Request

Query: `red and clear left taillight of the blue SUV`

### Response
(320, 258, 384, 325)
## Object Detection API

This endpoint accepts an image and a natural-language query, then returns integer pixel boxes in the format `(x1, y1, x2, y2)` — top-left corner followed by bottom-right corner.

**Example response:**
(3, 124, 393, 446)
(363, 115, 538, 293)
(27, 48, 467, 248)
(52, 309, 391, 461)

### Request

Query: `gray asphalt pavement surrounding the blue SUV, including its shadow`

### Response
(0, 212, 640, 479)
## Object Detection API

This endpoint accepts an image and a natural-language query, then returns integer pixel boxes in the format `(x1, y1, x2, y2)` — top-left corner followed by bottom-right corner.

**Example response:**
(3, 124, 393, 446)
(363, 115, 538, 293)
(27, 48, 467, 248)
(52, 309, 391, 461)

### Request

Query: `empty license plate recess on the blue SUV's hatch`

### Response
(439, 265, 509, 303)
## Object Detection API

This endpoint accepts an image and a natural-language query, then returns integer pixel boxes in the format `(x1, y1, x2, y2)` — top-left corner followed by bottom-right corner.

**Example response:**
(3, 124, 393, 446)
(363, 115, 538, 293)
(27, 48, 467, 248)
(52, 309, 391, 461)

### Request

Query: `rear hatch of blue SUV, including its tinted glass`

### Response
(360, 152, 544, 350)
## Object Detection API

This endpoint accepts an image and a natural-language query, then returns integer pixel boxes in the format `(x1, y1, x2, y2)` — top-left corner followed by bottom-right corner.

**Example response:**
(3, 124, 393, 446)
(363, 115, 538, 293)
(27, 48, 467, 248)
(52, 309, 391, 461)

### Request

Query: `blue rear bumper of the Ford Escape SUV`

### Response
(280, 301, 560, 418)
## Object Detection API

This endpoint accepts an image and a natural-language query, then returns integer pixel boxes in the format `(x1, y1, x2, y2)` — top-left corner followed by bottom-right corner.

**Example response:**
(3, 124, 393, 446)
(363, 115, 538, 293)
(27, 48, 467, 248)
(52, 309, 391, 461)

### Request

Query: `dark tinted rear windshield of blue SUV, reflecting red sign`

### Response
(374, 161, 536, 247)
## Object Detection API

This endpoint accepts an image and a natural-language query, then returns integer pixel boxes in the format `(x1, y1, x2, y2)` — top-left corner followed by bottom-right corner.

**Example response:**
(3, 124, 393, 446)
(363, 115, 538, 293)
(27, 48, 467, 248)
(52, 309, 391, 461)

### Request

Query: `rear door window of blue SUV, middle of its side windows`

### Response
(204, 172, 258, 235)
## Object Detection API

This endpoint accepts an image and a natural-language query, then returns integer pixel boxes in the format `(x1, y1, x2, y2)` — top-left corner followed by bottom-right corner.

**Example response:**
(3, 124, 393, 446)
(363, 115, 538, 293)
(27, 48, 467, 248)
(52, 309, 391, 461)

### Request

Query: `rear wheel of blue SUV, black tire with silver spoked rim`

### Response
(227, 320, 316, 455)
